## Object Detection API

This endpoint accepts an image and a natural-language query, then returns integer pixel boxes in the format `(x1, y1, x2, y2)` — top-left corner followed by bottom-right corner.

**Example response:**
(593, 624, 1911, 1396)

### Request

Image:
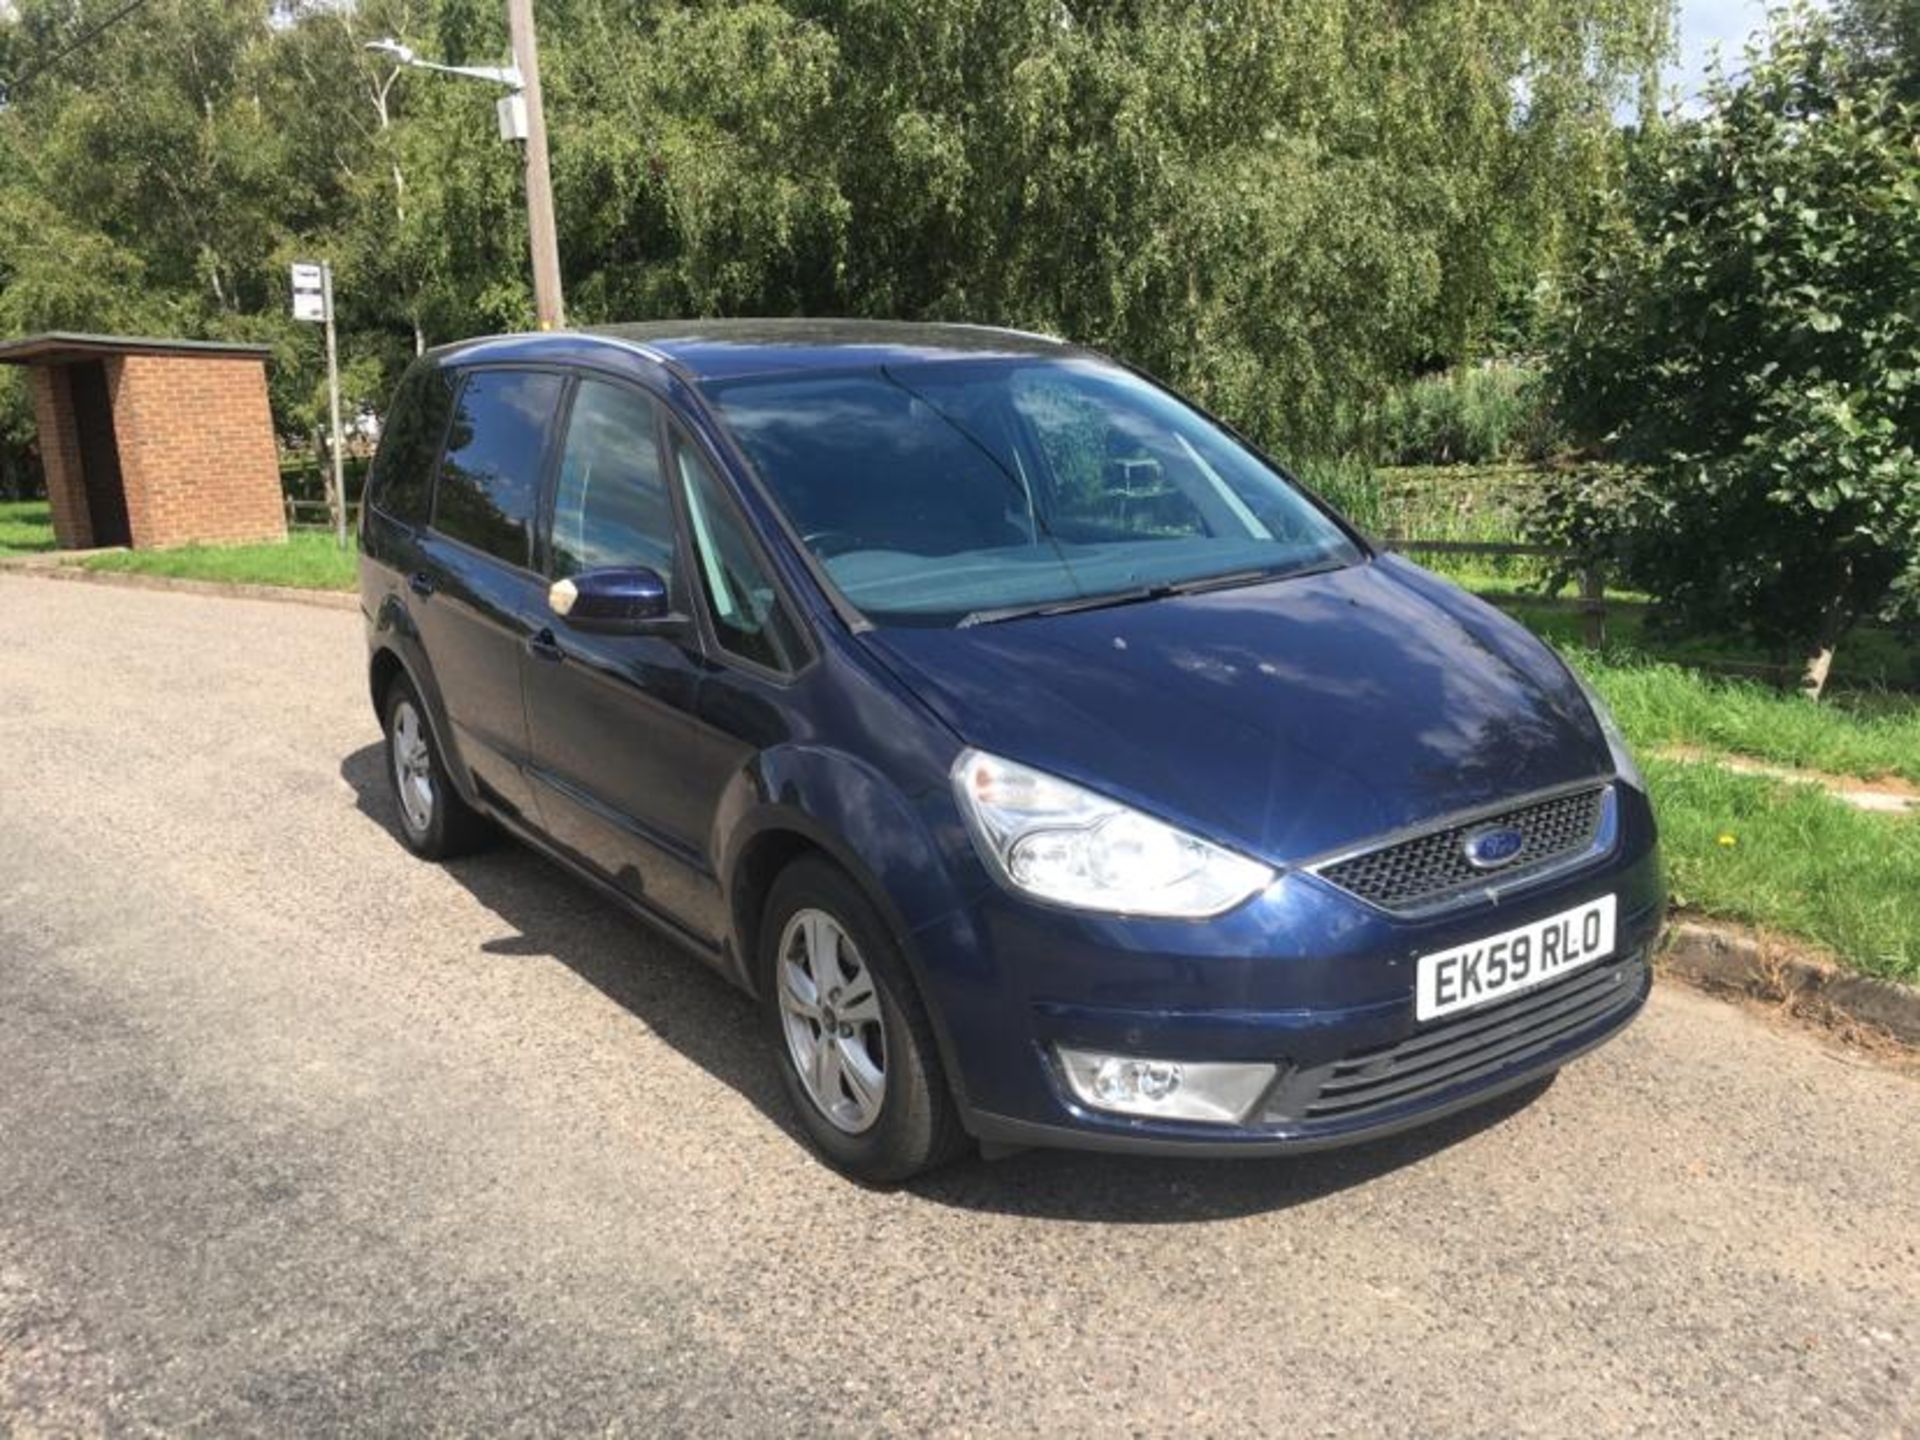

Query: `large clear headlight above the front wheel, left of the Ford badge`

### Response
(952, 751, 1275, 920)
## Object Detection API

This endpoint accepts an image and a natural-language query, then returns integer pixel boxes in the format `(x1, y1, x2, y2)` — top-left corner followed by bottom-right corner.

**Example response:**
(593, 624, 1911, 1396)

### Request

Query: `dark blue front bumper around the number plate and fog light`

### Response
(916, 795, 1665, 1154)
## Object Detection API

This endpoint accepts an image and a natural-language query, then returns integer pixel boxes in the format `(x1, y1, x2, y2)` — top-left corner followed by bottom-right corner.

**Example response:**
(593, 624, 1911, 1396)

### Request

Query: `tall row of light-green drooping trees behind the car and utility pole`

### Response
(0, 0, 1667, 462)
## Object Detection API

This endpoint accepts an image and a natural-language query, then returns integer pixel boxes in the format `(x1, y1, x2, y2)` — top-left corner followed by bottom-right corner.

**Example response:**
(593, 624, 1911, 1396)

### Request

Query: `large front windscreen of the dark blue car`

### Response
(712, 359, 1359, 626)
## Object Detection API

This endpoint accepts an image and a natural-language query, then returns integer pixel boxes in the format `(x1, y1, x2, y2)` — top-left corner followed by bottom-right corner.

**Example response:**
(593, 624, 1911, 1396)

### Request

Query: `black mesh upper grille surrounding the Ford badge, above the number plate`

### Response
(1319, 785, 1607, 910)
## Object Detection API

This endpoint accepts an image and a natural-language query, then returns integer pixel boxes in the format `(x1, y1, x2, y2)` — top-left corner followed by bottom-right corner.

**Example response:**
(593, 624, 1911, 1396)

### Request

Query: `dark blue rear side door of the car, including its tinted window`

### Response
(409, 369, 566, 824)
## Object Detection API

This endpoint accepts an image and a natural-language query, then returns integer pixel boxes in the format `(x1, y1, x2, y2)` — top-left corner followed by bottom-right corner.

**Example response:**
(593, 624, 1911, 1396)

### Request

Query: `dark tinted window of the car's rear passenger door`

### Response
(434, 371, 563, 566)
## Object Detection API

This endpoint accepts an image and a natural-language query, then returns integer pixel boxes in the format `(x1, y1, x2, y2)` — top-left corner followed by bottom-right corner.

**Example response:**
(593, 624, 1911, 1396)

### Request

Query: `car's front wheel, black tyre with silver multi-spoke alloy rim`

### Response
(758, 856, 968, 1185)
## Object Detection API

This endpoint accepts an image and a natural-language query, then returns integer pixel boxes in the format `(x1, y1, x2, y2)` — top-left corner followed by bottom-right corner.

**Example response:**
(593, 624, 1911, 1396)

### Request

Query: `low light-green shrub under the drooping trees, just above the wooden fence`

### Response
(1369, 365, 1559, 465)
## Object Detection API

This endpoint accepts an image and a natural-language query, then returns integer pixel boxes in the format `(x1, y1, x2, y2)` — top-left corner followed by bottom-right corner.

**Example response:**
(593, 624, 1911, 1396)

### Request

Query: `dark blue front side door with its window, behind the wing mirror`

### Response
(522, 378, 714, 939)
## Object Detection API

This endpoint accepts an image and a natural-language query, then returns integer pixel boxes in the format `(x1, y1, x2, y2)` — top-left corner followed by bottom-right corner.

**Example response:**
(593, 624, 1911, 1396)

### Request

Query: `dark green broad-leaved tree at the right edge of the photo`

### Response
(1540, 10, 1920, 653)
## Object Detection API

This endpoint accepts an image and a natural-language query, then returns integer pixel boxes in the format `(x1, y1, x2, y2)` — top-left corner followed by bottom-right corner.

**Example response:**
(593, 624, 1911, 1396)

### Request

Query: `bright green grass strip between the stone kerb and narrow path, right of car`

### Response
(1644, 756, 1920, 983)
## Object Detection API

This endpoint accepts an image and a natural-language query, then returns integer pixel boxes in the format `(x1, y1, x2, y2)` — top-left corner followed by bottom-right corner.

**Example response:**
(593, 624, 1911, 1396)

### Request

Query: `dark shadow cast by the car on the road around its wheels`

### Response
(340, 745, 1551, 1225)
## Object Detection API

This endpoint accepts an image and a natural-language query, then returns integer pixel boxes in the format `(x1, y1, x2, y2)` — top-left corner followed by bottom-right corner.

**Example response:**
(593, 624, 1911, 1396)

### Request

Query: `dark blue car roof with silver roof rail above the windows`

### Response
(434, 319, 1075, 382)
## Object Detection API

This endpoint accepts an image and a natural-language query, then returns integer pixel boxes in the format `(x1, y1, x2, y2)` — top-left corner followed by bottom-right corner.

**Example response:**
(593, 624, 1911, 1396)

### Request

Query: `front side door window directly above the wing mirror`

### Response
(553, 380, 674, 584)
